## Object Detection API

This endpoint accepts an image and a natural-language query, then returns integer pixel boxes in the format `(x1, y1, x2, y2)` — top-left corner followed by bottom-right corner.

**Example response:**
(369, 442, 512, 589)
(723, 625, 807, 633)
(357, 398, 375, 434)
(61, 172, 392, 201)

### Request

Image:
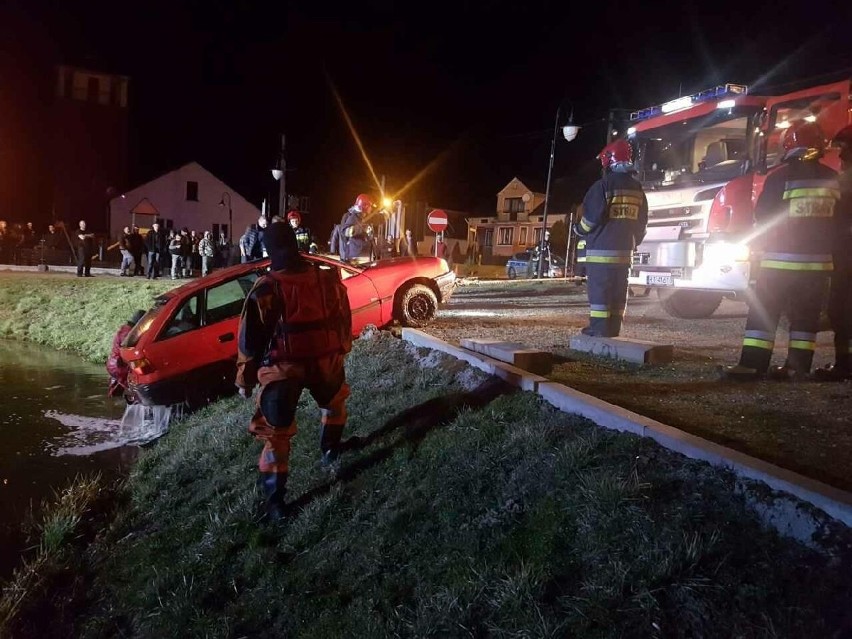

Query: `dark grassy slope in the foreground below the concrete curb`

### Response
(0, 332, 852, 638)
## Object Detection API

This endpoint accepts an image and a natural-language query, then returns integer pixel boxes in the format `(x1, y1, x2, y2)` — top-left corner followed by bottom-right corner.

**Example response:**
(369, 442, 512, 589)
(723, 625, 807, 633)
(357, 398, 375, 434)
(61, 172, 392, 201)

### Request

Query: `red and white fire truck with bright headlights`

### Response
(627, 78, 852, 319)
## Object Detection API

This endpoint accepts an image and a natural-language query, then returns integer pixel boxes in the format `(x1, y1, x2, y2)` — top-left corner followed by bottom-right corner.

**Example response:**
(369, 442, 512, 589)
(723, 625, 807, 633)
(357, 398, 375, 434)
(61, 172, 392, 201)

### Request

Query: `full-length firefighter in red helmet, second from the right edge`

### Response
(720, 120, 848, 380)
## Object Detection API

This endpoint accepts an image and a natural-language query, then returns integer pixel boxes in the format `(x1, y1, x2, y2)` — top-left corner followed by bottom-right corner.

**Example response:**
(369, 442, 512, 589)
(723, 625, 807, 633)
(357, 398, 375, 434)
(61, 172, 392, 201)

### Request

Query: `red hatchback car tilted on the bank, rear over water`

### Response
(121, 255, 456, 406)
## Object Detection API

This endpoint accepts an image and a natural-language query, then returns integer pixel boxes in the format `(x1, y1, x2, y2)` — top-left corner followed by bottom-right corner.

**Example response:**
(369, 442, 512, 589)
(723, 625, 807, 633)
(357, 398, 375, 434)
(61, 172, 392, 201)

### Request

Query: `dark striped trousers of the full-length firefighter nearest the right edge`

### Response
(740, 267, 828, 374)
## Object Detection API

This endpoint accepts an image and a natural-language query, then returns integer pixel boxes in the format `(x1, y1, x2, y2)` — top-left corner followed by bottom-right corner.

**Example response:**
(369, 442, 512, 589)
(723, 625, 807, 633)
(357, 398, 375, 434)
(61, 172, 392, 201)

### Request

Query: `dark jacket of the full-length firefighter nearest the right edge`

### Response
(753, 160, 840, 272)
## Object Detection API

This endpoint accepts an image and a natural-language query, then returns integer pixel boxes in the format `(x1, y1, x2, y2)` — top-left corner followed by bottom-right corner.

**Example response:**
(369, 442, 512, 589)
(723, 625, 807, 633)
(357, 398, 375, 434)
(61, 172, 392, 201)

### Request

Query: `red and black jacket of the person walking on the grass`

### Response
(236, 262, 352, 388)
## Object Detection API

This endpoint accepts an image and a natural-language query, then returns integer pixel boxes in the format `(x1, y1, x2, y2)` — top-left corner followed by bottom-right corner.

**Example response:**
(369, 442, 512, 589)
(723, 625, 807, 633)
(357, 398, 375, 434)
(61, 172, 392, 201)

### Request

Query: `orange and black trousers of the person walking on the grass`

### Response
(249, 355, 349, 476)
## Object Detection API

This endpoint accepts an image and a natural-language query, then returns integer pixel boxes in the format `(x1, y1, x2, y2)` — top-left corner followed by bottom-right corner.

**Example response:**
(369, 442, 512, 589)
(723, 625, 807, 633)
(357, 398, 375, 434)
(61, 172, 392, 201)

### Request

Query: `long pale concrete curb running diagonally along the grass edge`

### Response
(402, 328, 852, 538)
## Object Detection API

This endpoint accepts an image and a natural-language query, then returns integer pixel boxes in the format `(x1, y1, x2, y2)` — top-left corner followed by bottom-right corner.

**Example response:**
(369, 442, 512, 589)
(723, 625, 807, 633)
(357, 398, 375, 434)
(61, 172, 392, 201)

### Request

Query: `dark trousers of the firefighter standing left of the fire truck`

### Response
(583, 262, 630, 337)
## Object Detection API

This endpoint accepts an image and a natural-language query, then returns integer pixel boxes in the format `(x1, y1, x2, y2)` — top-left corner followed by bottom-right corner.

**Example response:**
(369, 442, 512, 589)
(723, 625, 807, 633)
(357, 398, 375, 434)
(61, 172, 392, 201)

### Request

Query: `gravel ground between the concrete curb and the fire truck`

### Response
(426, 280, 852, 490)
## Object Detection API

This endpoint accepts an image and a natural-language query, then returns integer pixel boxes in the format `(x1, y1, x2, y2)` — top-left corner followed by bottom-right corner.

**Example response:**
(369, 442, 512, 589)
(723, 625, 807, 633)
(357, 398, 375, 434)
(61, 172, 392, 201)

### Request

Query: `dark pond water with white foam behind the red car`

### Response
(0, 340, 138, 579)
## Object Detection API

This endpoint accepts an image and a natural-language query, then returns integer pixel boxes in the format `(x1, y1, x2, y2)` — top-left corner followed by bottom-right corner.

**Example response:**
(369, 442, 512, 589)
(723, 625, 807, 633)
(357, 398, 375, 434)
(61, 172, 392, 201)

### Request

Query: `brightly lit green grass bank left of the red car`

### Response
(0, 272, 175, 362)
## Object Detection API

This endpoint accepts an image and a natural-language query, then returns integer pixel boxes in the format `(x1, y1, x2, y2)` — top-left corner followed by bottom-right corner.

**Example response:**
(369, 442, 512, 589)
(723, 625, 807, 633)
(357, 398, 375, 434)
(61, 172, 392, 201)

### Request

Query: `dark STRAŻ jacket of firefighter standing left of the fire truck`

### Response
(577, 172, 648, 266)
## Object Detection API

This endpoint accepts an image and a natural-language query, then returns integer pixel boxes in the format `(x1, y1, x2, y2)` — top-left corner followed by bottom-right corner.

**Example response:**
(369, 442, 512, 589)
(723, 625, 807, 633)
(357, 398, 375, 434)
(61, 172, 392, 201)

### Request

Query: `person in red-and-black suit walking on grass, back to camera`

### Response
(236, 222, 352, 521)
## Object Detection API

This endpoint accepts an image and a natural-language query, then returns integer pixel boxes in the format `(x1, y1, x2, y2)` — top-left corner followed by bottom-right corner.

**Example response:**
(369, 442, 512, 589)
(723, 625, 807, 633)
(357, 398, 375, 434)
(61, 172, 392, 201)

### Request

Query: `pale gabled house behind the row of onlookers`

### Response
(109, 162, 260, 242)
